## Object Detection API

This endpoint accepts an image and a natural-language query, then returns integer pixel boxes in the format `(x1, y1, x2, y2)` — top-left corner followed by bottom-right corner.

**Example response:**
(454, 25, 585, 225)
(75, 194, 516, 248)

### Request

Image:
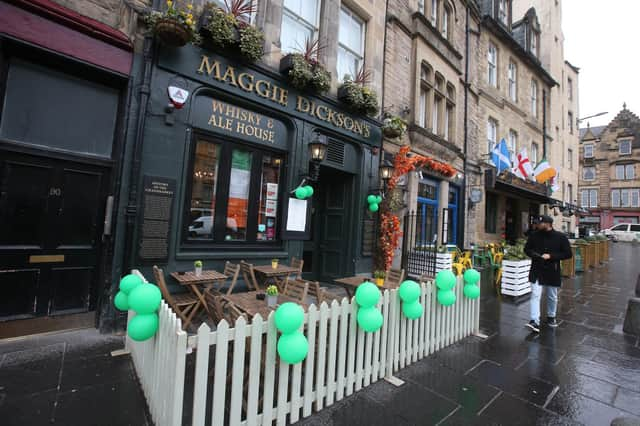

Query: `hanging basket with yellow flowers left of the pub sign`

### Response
(145, 0, 200, 47)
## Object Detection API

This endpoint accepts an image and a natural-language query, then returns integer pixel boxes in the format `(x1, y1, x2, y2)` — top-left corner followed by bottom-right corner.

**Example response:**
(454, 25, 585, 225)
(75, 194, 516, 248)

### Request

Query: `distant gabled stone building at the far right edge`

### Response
(579, 104, 640, 231)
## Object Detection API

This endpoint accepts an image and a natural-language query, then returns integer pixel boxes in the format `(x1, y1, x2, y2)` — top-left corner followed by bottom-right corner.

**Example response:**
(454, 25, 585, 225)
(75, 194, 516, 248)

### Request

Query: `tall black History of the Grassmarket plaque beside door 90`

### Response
(138, 176, 176, 263)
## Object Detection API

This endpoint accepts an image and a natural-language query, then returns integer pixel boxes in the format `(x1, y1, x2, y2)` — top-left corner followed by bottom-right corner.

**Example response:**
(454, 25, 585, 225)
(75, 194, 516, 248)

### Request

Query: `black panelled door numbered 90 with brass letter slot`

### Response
(0, 152, 108, 321)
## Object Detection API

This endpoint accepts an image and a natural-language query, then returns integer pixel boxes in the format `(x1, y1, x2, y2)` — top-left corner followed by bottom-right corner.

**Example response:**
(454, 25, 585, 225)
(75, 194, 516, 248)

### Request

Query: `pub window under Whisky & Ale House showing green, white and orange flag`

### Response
(185, 139, 284, 243)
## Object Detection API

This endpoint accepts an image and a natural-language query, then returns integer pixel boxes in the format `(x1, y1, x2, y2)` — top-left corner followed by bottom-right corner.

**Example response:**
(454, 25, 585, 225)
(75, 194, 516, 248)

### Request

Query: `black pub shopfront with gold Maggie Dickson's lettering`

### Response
(130, 46, 381, 292)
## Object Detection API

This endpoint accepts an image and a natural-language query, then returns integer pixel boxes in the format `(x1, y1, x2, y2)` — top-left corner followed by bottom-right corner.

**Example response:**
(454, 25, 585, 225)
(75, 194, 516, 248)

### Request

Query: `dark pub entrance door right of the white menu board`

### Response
(314, 167, 353, 282)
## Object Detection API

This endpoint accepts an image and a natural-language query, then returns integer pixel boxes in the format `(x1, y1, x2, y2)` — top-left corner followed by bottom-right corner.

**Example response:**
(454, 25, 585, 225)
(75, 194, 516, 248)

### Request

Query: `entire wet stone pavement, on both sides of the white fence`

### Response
(0, 243, 640, 426)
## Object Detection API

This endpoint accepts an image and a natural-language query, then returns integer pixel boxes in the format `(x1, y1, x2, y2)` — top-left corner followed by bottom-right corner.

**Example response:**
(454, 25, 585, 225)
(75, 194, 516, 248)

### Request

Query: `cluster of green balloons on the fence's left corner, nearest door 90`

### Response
(113, 274, 162, 342)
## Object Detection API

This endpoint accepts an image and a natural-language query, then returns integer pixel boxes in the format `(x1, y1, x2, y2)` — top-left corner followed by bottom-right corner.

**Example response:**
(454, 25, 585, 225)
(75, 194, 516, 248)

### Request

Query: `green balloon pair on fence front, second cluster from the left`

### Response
(275, 302, 309, 364)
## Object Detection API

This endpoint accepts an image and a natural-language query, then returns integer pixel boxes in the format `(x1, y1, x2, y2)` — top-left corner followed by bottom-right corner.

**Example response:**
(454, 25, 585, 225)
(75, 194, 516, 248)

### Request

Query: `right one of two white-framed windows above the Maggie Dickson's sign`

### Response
(336, 6, 365, 80)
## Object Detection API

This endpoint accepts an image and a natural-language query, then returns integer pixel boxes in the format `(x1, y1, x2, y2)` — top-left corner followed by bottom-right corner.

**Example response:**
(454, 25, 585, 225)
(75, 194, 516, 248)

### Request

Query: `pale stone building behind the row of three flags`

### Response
(475, 0, 557, 242)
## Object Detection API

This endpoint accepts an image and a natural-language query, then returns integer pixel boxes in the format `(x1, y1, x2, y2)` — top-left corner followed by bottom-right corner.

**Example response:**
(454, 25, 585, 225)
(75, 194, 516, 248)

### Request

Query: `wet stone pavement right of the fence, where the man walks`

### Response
(298, 243, 640, 426)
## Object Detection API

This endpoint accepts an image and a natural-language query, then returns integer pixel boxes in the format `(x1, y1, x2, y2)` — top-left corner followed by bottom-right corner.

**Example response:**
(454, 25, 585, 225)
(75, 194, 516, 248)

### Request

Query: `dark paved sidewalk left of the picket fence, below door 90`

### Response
(0, 329, 151, 426)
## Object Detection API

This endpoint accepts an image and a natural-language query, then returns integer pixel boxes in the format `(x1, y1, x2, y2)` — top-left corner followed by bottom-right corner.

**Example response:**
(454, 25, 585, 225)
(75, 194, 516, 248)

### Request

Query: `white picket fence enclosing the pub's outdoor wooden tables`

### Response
(127, 279, 480, 426)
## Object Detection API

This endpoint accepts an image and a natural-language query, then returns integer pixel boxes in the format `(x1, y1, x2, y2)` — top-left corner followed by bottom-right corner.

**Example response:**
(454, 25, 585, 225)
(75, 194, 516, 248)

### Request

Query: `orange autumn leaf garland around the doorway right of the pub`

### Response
(378, 145, 456, 271)
